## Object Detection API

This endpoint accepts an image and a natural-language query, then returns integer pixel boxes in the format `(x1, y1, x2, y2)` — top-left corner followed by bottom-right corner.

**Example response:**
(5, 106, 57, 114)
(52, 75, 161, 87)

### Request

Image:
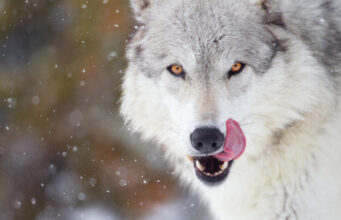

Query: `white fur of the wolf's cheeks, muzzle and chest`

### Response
(121, 0, 341, 220)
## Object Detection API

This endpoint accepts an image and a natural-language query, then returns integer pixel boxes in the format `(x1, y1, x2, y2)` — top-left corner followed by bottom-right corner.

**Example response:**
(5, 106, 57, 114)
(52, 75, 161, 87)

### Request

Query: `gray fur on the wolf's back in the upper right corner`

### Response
(267, 0, 341, 72)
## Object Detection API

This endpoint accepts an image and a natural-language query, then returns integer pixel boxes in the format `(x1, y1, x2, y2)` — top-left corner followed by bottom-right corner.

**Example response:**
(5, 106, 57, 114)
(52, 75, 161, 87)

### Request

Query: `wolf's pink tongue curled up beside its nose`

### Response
(215, 119, 246, 161)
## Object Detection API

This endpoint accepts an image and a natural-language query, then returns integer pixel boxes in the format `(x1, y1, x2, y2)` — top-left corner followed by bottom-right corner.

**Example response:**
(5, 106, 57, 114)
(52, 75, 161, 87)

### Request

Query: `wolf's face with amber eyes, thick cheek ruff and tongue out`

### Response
(122, 0, 329, 186)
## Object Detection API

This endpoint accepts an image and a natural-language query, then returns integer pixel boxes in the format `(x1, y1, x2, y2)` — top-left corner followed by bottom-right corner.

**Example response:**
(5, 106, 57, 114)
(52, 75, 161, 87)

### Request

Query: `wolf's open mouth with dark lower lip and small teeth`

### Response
(193, 156, 233, 185)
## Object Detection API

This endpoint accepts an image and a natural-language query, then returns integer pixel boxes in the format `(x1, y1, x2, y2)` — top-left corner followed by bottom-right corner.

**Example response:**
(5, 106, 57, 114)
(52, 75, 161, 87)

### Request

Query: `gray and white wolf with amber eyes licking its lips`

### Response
(121, 0, 341, 220)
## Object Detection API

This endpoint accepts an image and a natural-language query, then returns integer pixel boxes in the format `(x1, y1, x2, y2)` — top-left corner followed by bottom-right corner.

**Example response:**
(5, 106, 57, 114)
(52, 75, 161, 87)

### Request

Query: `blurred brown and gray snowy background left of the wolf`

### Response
(0, 0, 210, 220)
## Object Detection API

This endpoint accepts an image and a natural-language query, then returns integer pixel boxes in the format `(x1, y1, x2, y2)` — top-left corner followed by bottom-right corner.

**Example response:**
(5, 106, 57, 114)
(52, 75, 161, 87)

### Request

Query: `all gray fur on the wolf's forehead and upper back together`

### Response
(129, 0, 341, 75)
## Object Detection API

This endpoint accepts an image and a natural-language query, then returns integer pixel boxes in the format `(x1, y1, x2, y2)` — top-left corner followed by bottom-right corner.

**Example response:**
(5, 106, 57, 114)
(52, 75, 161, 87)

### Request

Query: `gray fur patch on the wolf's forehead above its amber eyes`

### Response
(128, 1, 276, 79)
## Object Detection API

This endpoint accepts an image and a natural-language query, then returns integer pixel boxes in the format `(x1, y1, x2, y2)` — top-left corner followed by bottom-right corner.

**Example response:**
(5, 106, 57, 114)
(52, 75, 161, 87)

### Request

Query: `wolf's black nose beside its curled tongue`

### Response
(190, 127, 225, 154)
